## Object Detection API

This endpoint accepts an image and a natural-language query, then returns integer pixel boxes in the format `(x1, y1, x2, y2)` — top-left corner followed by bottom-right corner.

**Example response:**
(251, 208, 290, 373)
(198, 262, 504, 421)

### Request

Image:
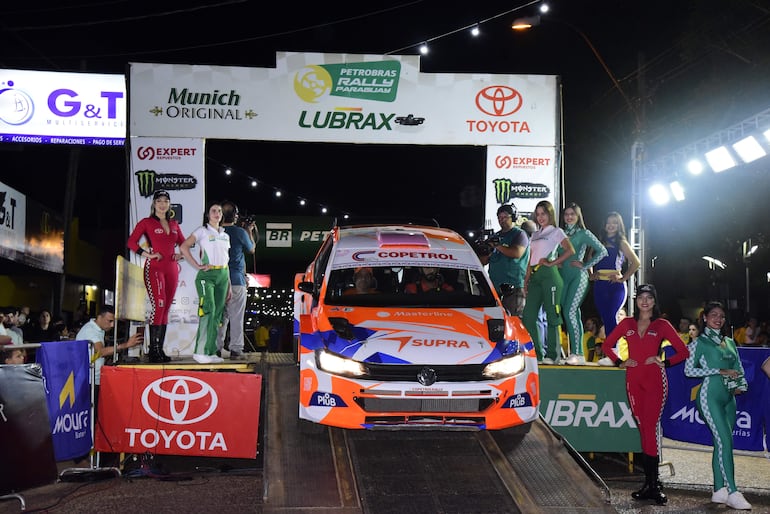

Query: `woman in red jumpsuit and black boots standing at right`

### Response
(602, 284, 690, 505)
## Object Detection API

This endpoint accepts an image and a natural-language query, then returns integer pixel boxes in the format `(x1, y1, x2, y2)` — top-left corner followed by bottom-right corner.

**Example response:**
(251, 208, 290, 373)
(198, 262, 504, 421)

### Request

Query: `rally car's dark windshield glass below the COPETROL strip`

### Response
(325, 266, 495, 307)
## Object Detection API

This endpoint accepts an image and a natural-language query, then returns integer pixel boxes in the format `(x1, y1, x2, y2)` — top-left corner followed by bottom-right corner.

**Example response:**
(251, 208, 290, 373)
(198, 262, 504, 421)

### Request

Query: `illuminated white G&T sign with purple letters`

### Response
(0, 69, 127, 146)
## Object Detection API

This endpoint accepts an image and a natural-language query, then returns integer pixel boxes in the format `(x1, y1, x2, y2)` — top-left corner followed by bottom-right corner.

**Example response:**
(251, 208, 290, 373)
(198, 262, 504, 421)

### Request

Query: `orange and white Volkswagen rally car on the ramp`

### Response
(294, 220, 540, 430)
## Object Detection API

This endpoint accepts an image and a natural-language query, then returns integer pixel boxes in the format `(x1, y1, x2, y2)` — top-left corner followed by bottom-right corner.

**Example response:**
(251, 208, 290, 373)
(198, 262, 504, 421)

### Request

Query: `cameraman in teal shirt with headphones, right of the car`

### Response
(476, 205, 529, 316)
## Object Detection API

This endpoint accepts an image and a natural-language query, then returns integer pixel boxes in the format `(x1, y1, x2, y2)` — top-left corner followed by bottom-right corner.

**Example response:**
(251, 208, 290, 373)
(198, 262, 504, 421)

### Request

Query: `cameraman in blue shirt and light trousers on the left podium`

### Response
(217, 201, 257, 360)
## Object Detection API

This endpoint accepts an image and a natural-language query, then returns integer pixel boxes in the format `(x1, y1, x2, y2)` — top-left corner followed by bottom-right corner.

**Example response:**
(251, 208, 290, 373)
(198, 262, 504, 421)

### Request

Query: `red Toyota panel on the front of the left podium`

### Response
(95, 366, 262, 459)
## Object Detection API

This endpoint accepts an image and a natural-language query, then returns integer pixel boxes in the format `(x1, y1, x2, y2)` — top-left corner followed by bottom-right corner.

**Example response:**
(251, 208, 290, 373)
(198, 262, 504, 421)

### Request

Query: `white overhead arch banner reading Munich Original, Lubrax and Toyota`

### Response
(129, 53, 558, 146)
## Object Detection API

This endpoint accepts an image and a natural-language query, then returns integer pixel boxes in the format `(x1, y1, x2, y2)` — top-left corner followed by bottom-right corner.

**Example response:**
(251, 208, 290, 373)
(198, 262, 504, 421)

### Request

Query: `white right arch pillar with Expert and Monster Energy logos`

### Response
(484, 146, 560, 225)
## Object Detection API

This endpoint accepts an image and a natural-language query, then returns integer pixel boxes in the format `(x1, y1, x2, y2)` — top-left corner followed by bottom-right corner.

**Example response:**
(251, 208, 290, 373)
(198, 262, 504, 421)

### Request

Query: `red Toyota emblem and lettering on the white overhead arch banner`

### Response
(466, 85, 530, 133)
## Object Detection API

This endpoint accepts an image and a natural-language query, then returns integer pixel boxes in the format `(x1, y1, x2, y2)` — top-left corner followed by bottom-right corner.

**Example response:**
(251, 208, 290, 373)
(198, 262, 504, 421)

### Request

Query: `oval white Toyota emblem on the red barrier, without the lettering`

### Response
(142, 375, 219, 425)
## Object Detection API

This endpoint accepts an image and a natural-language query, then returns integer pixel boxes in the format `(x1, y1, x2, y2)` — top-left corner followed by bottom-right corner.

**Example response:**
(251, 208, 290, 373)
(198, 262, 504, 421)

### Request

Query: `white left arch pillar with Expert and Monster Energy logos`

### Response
(129, 137, 206, 356)
